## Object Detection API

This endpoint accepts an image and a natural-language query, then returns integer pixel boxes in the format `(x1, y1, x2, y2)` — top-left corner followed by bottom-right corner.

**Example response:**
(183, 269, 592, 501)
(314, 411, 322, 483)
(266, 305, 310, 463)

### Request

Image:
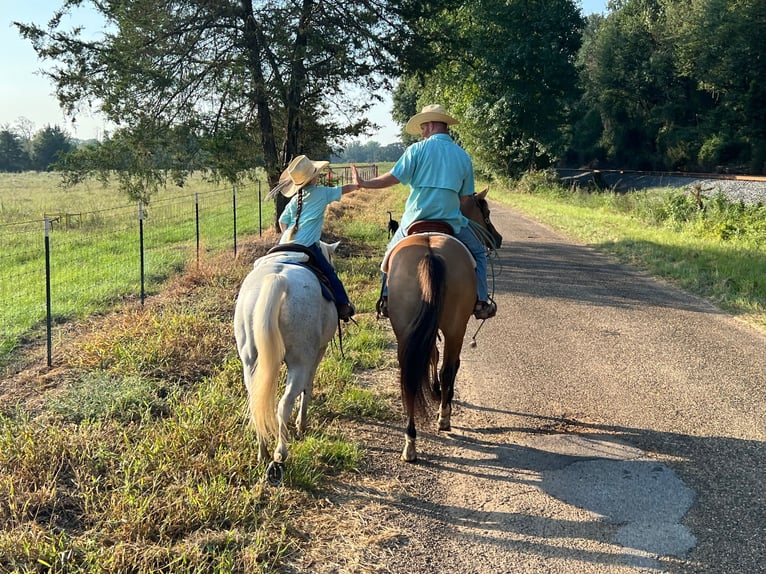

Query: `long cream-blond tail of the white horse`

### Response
(250, 273, 287, 438)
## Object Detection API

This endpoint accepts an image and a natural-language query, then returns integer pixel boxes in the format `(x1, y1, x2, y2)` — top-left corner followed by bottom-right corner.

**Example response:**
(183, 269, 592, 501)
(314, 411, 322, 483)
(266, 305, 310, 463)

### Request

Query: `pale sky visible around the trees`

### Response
(0, 0, 607, 145)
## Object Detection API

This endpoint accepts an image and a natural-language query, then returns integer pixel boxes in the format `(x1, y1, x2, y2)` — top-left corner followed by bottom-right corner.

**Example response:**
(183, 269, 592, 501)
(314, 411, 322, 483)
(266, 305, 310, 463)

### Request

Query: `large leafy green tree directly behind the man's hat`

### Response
(401, 0, 583, 175)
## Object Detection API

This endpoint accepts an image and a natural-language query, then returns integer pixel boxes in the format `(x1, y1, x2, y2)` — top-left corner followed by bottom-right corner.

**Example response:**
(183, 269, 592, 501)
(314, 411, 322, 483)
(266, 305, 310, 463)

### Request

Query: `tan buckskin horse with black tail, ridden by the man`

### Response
(387, 189, 503, 462)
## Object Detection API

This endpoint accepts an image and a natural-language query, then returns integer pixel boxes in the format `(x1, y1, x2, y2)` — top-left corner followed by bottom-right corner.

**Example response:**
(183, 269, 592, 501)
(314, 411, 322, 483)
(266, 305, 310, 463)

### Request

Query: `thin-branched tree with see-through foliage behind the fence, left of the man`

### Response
(16, 0, 402, 214)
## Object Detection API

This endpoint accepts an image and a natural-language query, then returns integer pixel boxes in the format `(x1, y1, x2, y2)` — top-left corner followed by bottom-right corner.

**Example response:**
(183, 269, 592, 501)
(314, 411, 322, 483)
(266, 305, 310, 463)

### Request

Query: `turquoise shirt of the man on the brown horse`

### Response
(391, 134, 474, 233)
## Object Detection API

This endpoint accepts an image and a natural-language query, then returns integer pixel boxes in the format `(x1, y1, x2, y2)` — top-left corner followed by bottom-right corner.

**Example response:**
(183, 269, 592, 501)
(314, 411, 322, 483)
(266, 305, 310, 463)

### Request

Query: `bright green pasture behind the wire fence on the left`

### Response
(0, 173, 274, 366)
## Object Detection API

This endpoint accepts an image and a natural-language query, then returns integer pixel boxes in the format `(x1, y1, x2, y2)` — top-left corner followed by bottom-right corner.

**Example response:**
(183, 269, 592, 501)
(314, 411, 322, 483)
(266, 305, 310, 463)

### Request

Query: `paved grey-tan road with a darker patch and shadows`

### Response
(368, 205, 766, 574)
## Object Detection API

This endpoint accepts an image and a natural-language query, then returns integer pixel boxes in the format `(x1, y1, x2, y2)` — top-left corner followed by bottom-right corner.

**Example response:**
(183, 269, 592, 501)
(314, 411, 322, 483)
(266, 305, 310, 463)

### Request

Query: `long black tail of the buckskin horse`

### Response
(399, 249, 447, 414)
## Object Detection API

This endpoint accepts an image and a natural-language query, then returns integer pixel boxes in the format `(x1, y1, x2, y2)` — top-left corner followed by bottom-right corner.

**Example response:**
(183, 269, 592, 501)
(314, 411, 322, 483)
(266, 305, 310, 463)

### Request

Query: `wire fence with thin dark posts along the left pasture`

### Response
(0, 165, 378, 369)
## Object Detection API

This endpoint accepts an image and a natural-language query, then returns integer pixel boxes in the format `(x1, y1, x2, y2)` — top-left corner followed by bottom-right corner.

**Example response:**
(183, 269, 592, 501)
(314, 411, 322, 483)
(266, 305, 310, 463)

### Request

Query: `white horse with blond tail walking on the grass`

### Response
(234, 243, 338, 484)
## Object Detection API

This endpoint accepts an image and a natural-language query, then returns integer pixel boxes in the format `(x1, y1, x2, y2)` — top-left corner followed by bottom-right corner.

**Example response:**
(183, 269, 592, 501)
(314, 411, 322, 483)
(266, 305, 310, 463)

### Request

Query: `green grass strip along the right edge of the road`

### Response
(492, 174, 766, 328)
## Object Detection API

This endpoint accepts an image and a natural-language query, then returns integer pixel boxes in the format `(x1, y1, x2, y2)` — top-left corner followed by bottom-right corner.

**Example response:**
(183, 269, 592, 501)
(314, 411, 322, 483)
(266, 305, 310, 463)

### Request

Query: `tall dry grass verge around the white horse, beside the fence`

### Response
(0, 182, 398, 573)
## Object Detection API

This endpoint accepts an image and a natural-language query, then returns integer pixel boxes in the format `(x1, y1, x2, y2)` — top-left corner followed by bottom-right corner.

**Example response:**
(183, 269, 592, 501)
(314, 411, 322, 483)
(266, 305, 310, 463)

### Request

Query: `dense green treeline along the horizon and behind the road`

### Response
(0, 0, 766, 179)
